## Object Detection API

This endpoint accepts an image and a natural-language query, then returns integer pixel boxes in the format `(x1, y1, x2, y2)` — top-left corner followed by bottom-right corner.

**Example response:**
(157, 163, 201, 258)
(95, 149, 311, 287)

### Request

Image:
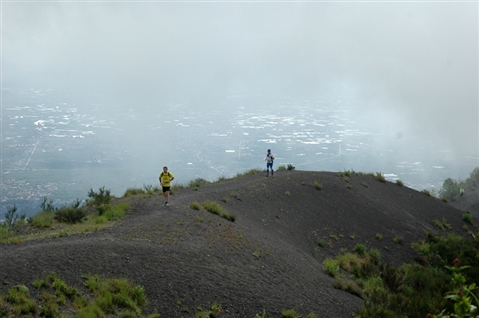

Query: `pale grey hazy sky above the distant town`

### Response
(1, 1, 479, 155)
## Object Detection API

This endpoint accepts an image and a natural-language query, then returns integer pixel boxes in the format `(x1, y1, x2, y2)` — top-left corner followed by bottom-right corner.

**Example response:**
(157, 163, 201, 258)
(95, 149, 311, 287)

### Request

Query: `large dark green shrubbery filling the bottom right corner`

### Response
(330, 233, 479, 318)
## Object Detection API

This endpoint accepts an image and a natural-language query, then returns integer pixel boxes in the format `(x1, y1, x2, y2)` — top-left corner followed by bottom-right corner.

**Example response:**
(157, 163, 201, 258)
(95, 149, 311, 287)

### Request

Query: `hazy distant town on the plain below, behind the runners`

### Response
(0, 88, 474, 219)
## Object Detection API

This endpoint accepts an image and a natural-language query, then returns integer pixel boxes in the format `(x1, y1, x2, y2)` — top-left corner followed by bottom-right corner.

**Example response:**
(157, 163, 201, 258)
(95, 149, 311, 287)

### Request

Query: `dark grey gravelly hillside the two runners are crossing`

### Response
(0, 171, 474, 318)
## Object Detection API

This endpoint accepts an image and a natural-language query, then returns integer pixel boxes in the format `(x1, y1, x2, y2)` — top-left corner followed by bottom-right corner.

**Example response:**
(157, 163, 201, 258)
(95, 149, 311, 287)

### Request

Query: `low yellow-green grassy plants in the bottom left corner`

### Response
(0, 273, 159, 318)
